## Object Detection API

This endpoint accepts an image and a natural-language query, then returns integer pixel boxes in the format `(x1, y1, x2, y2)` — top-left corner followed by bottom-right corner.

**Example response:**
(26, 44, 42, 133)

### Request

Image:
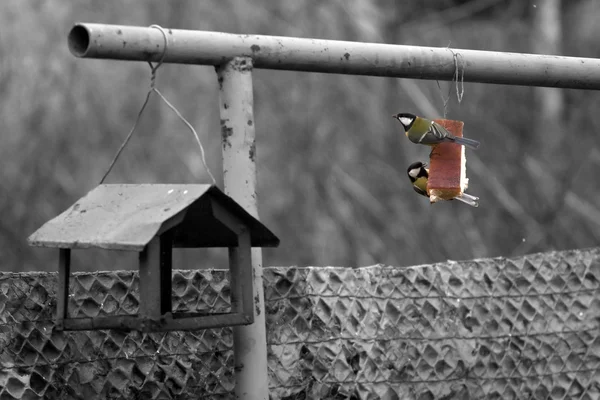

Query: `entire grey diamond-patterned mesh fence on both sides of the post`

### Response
(0, 249, 600, 400)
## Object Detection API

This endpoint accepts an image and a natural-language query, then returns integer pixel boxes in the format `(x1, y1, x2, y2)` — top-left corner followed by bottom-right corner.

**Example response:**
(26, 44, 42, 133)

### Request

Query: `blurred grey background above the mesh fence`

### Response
(0, 0, 600, 271)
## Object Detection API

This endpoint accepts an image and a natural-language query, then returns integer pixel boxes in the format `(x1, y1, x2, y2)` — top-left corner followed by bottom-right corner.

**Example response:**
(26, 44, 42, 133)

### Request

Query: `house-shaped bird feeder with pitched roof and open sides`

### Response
(28, 184, 279, 332)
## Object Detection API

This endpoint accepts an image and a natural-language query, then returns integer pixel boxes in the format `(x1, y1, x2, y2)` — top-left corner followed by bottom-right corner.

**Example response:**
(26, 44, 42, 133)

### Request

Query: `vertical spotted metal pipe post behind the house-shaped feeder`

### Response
(217, 57, 269, 400)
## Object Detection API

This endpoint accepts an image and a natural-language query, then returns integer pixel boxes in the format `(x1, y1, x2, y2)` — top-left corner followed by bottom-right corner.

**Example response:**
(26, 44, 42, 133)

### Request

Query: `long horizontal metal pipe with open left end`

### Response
(68, 23, 600, 90)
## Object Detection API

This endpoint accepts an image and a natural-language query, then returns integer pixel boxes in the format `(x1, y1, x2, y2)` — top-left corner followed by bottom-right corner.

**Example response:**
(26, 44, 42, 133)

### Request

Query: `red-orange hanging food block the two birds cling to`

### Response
(427, 119, 479, 207)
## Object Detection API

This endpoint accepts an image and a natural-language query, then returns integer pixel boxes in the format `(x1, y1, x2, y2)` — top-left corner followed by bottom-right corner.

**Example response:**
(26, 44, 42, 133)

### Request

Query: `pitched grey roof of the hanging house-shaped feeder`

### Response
(28, 184, 279, 251)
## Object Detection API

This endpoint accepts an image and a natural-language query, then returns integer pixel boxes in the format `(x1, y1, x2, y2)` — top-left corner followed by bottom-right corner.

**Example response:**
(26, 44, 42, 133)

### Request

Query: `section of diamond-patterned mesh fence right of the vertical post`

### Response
(266, 253, 600, 399)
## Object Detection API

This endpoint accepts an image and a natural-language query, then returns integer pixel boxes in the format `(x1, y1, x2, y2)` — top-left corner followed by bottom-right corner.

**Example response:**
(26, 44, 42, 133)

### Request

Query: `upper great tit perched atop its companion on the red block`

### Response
(392, 113, 479, 149)
